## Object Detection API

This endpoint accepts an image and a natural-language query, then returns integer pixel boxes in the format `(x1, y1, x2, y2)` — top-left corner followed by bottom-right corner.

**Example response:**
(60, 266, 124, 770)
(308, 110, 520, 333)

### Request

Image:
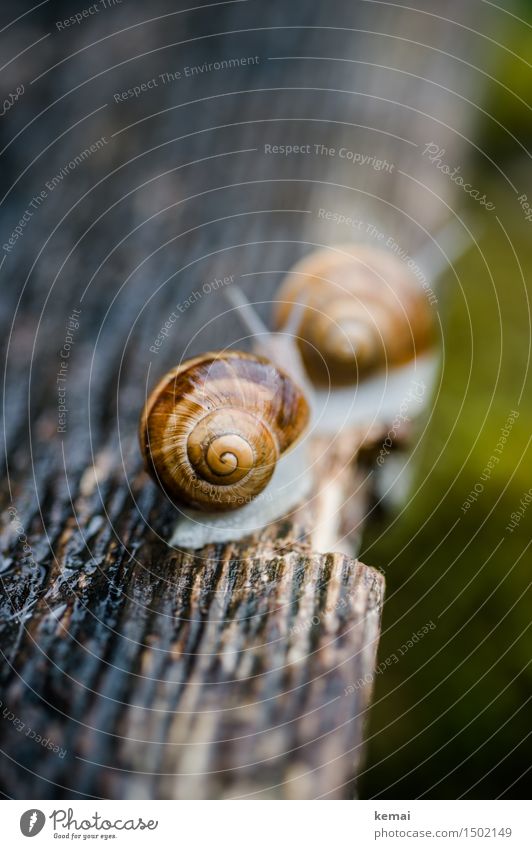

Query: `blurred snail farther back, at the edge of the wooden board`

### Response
(266, 222, 473, 502)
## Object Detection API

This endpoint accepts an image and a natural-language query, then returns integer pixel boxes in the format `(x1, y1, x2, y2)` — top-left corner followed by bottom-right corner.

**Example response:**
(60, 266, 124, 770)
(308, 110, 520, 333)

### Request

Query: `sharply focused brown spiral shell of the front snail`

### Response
(139, 351, 310, 511)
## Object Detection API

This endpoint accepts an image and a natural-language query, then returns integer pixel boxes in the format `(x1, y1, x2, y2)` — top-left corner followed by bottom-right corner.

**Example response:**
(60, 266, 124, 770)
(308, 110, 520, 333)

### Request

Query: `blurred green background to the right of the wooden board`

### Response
(360, 3, 532, 798)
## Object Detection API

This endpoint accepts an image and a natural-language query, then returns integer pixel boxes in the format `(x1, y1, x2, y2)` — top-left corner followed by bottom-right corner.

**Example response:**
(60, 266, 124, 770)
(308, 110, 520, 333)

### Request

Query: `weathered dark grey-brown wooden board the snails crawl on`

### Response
(0, 0, 485, 798)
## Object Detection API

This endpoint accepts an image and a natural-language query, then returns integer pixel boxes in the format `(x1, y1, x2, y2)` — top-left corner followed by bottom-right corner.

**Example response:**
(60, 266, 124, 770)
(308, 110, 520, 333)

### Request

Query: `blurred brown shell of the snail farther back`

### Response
(274, 245, 433, 384)
